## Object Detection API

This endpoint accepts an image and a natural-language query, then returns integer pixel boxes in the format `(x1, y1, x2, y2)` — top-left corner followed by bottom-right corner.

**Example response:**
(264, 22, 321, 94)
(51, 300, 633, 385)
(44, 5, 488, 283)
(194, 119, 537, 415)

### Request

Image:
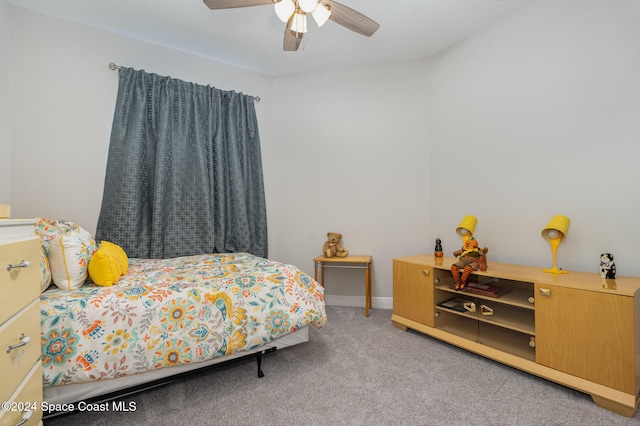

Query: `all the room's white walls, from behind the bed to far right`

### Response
(8, 0, 640, 312)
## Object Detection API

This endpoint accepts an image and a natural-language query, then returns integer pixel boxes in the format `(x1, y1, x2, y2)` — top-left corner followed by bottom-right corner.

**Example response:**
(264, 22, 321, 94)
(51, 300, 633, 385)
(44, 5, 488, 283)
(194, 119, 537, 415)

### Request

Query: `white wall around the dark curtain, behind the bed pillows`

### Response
(10, 8, 273, 246)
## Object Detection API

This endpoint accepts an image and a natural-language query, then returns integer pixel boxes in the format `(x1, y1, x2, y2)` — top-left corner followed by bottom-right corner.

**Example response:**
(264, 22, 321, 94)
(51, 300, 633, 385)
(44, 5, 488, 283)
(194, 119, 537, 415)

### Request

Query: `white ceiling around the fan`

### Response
(8, 0, 535, 76)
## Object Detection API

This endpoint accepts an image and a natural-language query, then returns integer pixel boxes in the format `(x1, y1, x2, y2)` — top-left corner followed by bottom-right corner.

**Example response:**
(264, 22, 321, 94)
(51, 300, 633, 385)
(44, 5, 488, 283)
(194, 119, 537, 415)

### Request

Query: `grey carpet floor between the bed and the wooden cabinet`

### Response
(45, 307, 640, 426)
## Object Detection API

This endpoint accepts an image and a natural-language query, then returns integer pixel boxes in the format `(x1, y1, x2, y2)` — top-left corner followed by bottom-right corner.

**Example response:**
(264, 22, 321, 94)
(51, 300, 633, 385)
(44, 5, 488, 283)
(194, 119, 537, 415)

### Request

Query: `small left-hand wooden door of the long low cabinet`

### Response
(393, 261, 434, 327)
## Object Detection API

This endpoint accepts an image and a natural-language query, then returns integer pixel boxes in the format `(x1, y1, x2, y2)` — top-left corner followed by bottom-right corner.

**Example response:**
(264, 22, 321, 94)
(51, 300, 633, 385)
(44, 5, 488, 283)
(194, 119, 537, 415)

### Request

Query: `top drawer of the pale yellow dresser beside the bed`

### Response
(0, 237, 40, 324)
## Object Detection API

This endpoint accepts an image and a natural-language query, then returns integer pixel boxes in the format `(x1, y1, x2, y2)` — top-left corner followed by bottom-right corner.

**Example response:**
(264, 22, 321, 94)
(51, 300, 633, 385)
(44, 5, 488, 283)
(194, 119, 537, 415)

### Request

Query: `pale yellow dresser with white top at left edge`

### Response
(0, 219, 42, 426)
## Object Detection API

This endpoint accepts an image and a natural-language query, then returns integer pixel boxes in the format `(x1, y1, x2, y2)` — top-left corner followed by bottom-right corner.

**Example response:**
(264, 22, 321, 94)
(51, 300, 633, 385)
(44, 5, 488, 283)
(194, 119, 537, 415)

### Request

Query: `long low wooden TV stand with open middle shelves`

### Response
(391, 254, 640, 417)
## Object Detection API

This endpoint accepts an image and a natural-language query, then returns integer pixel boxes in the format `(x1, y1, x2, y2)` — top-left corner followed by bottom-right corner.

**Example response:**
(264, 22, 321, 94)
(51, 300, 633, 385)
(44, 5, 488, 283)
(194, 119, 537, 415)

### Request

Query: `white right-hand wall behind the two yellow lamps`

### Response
(429, 0, 640, 276)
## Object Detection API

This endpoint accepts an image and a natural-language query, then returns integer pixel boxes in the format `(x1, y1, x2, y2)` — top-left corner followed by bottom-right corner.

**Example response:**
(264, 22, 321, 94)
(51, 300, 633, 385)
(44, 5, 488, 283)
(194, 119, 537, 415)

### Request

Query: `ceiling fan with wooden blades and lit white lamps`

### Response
(204, 0, 380, 51)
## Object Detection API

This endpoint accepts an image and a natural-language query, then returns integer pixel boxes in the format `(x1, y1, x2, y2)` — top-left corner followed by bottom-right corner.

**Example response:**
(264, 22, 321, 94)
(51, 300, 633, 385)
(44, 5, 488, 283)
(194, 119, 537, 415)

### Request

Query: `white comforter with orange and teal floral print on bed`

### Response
(41, 253, 326, 387)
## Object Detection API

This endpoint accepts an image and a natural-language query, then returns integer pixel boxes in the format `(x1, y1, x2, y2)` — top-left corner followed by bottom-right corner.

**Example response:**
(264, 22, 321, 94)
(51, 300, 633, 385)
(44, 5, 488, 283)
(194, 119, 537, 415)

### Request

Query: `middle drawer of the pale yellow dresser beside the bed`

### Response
(0, 299, 42, 401)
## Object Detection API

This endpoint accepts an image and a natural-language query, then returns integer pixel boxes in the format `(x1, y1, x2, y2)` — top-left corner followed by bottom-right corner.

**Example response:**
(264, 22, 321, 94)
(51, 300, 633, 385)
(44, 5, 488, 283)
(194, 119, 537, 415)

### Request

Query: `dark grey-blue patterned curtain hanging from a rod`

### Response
(96, 68, 267, 258)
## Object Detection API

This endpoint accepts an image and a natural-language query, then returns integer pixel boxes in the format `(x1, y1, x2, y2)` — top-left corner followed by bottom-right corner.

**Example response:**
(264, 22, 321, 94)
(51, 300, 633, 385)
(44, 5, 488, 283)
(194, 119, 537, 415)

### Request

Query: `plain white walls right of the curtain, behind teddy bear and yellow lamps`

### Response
(271, 0, 640, 305)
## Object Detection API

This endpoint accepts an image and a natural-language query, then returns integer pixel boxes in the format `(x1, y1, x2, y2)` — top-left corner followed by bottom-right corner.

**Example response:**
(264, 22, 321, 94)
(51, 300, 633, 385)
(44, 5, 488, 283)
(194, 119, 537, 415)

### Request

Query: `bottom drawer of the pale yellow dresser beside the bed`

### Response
(0, 361, 42, 426)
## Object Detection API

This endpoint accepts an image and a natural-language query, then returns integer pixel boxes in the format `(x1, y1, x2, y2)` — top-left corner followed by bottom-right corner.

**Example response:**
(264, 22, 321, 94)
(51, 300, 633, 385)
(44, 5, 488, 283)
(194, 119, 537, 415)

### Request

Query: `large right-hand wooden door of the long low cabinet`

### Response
(535, 285, 637, 395)
